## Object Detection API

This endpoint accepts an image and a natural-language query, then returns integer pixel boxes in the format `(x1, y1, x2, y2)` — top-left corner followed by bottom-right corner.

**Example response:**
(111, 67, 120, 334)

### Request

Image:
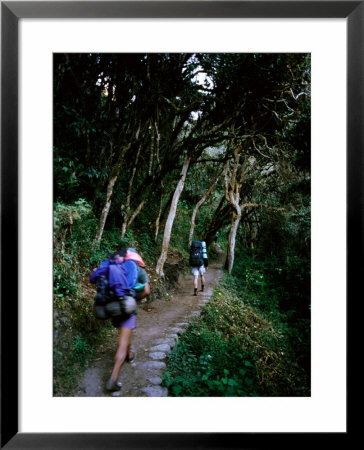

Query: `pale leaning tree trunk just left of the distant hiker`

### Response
(156, 155, 191, 277)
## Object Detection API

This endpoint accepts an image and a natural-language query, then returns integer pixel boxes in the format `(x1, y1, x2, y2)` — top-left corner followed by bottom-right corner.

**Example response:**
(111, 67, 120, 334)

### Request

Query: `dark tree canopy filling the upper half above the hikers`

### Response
(54, 53, 310, 274)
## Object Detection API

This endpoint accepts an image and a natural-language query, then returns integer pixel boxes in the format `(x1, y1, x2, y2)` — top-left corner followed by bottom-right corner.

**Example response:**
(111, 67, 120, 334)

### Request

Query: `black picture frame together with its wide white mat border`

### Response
(1, 0, 356, 449)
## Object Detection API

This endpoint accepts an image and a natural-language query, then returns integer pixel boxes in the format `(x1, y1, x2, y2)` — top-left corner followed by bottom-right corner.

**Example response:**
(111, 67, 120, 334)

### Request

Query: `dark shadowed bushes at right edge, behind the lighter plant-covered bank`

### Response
(230, 236, 311, 386)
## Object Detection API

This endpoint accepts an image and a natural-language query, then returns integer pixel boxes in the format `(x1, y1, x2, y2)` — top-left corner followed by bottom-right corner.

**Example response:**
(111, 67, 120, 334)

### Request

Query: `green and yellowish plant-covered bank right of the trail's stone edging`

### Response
(163, 274, 309, 397)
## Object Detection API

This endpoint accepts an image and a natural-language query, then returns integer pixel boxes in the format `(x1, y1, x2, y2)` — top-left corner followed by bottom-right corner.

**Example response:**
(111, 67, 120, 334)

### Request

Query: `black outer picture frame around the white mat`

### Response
(1, 0, 358, 449)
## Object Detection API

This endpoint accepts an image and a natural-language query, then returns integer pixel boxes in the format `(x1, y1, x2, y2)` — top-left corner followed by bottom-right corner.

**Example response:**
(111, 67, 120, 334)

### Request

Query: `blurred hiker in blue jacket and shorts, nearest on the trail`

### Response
(90, 249, 150, 391)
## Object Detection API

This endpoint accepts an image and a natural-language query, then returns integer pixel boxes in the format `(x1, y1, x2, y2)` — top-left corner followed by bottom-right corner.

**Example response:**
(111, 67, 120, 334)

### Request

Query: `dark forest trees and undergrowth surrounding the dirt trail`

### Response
(54, 53, 310, 396)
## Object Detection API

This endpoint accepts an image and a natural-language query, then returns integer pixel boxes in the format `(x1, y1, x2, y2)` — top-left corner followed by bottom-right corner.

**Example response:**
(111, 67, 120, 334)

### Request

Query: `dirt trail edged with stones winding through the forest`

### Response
(73, 245, 225, 397)
